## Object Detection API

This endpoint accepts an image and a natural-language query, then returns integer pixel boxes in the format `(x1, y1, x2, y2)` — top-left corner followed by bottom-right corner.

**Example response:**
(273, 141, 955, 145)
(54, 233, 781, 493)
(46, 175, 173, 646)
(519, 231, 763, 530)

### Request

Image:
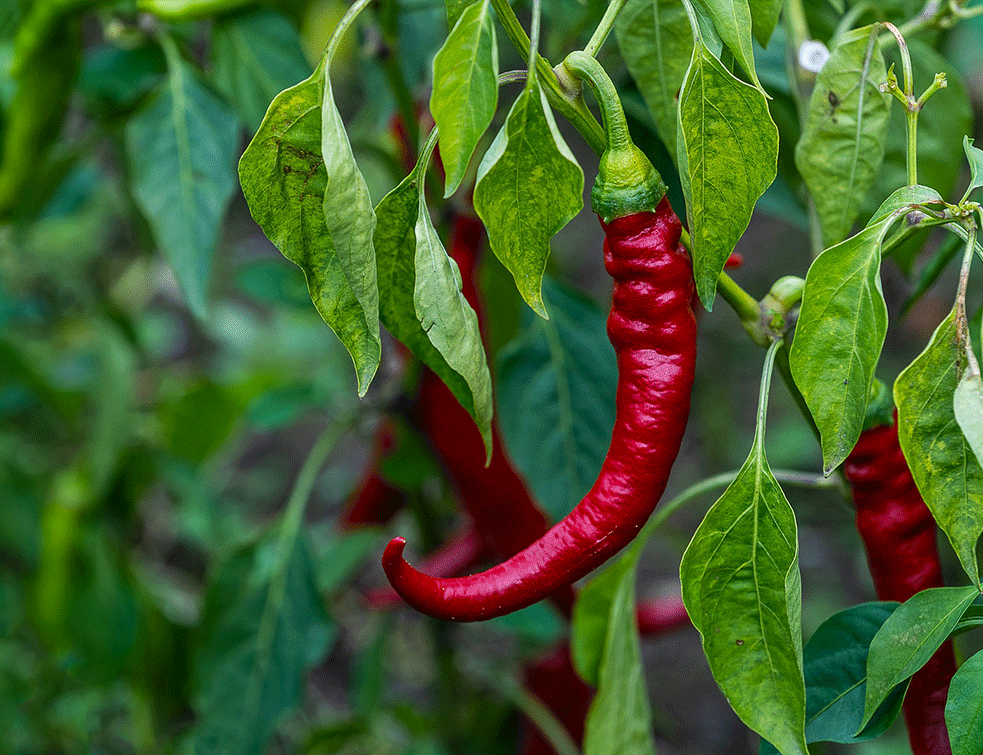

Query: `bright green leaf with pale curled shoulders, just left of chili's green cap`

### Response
(474, 78, 584, 318)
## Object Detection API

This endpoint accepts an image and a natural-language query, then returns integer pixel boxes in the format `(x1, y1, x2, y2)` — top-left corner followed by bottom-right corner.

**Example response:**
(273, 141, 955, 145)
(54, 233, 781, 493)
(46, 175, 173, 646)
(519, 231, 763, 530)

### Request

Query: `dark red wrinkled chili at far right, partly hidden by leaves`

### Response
(843, 415, 956, 755)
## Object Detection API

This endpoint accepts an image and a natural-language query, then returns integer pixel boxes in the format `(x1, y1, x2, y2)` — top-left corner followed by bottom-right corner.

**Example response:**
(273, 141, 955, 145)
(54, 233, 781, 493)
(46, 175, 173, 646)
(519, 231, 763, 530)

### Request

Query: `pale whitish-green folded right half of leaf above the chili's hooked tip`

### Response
(413, 193, 492, 461)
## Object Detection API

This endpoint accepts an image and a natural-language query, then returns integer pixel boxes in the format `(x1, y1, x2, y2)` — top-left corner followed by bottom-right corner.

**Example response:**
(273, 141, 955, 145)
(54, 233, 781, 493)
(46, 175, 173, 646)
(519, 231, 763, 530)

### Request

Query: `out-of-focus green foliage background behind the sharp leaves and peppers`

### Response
(0, 0, 983, 755)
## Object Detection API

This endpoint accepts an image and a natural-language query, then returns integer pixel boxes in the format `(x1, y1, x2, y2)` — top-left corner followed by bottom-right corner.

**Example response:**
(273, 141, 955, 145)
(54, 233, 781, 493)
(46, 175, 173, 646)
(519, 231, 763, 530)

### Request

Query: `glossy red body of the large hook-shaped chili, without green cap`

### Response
(382, 198, 696, 621)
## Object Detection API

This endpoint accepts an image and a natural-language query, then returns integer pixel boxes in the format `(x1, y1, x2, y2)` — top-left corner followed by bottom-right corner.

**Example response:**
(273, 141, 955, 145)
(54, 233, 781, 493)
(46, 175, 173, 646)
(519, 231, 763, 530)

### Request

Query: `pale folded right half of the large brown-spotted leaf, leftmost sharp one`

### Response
(319, 58, 380, 396)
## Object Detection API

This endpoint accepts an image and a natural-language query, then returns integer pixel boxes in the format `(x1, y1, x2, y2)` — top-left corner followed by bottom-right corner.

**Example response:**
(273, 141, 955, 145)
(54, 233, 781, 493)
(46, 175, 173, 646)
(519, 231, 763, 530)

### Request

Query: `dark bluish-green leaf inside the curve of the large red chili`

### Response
(497, 278, 618, 519)
